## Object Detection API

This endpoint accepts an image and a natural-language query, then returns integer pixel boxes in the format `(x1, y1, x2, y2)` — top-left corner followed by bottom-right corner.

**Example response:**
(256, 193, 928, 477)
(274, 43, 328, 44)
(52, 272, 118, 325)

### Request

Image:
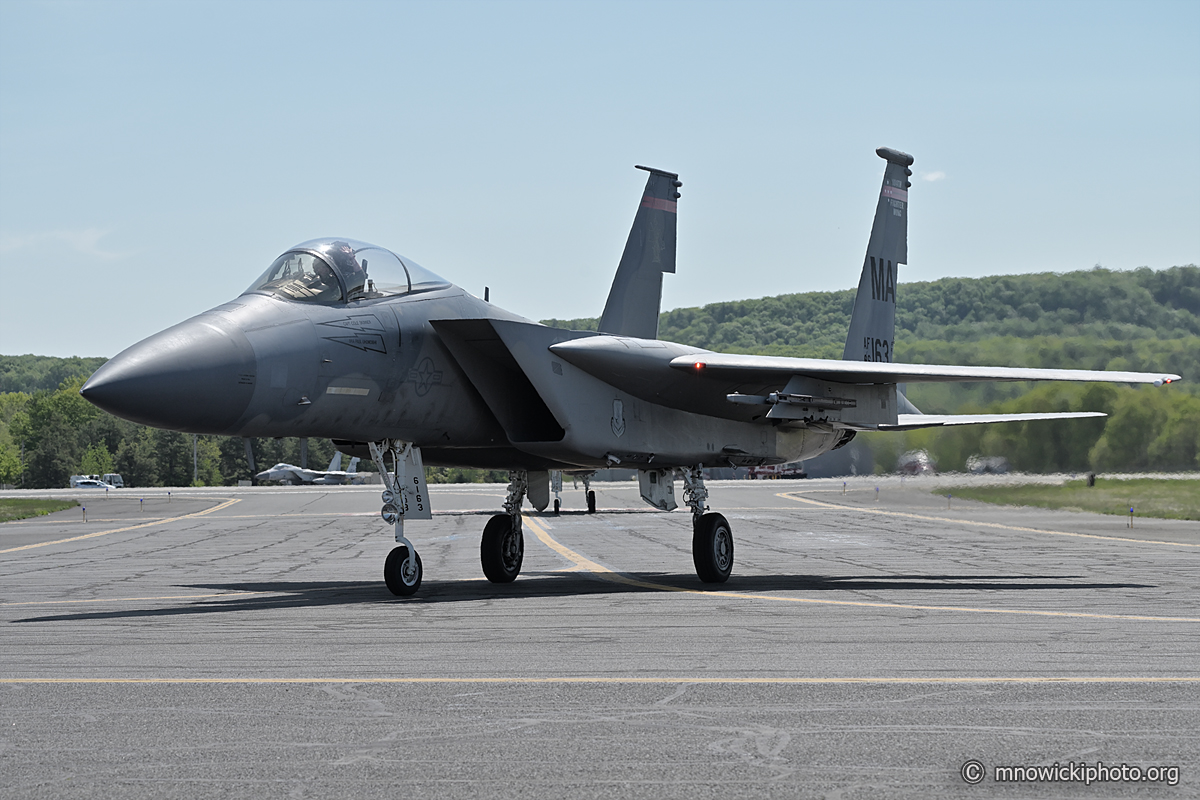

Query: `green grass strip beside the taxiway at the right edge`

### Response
(936, 477, 1200, 519)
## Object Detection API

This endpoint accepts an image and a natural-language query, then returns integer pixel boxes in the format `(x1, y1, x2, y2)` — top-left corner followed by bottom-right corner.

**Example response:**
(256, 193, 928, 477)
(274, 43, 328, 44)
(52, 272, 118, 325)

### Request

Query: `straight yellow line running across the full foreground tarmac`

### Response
(0, 675, 1200, 686)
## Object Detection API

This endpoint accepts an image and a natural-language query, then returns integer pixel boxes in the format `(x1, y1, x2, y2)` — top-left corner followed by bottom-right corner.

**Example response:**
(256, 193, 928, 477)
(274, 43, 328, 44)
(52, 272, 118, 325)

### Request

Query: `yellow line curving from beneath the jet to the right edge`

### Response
(524, 517, 1200, 622)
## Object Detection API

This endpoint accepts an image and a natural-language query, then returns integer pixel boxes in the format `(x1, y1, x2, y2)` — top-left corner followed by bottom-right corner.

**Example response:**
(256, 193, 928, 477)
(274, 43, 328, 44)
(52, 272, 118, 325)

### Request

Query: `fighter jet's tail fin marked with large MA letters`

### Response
(841, 148, 912, 361)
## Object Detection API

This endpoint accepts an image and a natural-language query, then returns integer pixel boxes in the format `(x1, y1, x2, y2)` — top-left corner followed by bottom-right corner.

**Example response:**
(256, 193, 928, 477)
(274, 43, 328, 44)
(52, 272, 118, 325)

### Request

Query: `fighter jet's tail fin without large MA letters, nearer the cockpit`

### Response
(600, 167, 683, 339)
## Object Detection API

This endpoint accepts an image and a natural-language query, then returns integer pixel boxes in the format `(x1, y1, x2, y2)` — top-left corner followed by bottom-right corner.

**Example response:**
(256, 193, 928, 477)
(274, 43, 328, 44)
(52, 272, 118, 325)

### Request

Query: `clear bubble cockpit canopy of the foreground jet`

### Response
(242, 239, 448, 303)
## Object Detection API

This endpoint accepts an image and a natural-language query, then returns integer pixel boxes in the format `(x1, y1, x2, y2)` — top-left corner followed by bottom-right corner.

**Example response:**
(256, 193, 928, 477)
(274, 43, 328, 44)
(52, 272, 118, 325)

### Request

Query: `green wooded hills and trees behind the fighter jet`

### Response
(0, 266, 1200, 487)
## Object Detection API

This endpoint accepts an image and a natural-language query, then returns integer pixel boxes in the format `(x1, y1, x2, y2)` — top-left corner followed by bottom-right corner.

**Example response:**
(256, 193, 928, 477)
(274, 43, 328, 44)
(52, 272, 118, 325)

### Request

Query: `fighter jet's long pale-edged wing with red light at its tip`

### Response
(671, 351, 1180, 386)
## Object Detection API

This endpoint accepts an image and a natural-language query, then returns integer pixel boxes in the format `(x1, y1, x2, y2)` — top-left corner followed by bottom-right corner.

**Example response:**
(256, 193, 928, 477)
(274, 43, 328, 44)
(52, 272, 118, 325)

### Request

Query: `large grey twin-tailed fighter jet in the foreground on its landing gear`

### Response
(82, 148, 1180, 596)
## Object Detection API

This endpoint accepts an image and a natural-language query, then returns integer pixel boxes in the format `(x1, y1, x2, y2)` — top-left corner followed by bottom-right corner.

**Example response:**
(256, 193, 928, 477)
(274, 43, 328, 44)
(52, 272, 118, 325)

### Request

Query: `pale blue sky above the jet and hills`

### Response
(0, 0, 1200, 355)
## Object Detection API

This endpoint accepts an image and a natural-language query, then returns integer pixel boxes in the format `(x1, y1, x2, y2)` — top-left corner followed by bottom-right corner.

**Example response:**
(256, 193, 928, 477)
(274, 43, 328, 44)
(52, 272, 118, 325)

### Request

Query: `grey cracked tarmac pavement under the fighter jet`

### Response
(0, 479, 1200, 799)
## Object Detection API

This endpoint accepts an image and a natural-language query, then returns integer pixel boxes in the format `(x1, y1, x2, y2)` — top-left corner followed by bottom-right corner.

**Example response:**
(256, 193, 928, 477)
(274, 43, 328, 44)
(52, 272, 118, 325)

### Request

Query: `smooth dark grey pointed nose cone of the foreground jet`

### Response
(79, 315, 256, 433)
